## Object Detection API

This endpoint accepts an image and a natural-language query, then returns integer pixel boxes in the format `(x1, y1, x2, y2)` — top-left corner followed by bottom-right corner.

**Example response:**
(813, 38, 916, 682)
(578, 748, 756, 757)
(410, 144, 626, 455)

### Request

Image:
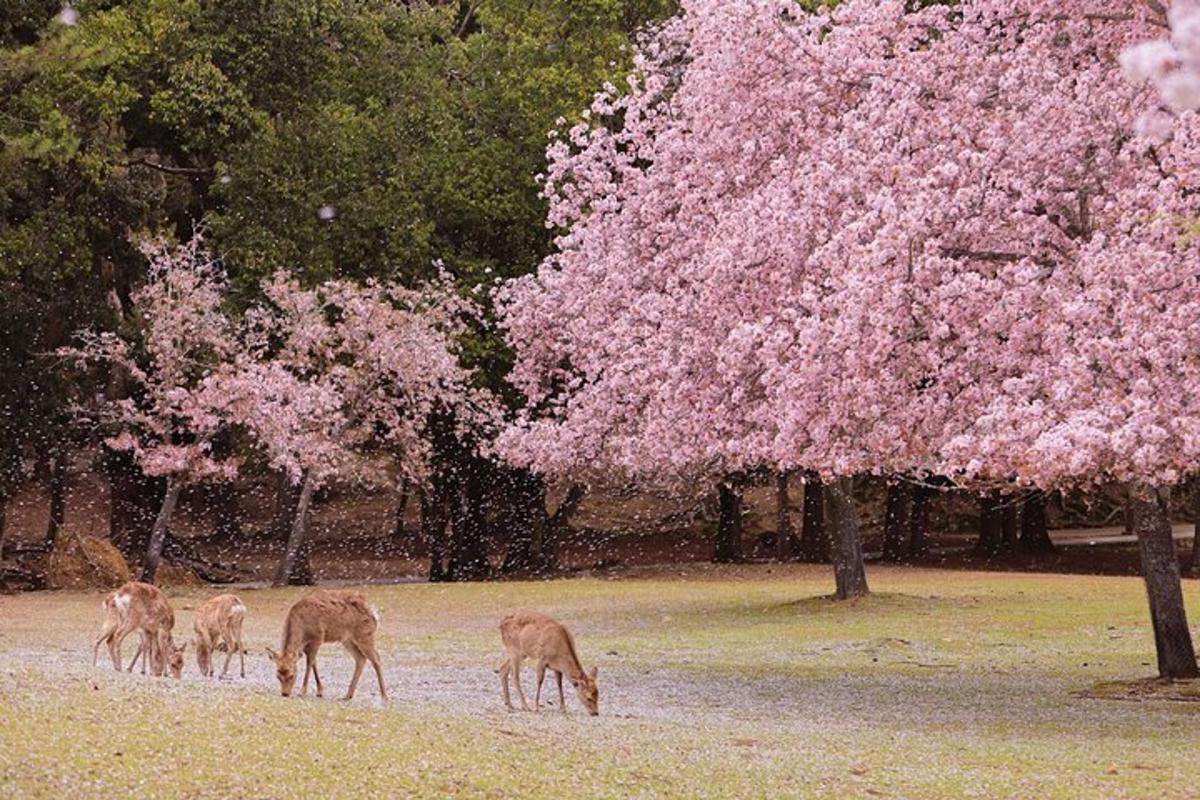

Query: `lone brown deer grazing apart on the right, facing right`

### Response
(500, 612, 600, 716)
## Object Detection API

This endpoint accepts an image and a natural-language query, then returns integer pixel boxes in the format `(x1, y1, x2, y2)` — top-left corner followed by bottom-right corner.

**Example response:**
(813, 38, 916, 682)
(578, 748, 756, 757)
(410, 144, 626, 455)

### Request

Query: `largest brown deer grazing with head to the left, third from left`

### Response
(266, 591, 388, 703)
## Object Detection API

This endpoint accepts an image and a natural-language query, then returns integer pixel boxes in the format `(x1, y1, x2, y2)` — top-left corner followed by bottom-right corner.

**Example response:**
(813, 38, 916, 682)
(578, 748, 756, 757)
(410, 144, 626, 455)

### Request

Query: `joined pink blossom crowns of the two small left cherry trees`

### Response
(68, 237, 487, 486)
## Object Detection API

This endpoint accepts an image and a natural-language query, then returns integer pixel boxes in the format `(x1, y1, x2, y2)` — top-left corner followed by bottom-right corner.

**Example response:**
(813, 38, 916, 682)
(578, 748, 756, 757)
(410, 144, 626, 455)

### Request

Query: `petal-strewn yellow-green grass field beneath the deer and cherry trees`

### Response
(0, 566, 1200, 799)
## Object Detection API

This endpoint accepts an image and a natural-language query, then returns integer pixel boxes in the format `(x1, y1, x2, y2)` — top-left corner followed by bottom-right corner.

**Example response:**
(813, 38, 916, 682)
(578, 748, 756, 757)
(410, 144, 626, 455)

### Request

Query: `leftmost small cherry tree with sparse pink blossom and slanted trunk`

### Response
(62, 236, 239, 582)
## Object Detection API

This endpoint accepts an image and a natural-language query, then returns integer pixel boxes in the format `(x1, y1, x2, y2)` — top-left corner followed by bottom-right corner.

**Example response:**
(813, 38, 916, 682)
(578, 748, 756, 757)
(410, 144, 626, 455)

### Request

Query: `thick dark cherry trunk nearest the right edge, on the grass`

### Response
(1129, 485, 1200, 678)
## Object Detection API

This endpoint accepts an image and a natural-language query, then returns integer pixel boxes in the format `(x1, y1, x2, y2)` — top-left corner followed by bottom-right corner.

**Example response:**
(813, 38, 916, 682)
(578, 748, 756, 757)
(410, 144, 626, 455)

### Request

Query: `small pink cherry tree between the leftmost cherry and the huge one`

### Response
(224, 272, 497, 584)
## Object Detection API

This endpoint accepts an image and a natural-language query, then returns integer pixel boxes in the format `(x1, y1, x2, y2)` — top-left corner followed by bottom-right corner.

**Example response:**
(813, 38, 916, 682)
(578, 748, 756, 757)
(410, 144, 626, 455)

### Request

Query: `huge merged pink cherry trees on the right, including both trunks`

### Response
(499, 0, 1200, 676)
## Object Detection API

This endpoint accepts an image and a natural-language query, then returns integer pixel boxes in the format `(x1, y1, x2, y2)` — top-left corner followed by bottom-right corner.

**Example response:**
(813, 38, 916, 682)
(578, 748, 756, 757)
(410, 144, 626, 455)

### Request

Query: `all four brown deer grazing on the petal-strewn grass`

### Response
(91, 582, 600, 716)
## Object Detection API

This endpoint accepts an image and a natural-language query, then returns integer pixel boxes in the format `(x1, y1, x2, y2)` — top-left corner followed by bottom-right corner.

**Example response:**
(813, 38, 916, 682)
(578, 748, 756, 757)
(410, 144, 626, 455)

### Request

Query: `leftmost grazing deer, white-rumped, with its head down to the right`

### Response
(104, 581, 187, 678)
